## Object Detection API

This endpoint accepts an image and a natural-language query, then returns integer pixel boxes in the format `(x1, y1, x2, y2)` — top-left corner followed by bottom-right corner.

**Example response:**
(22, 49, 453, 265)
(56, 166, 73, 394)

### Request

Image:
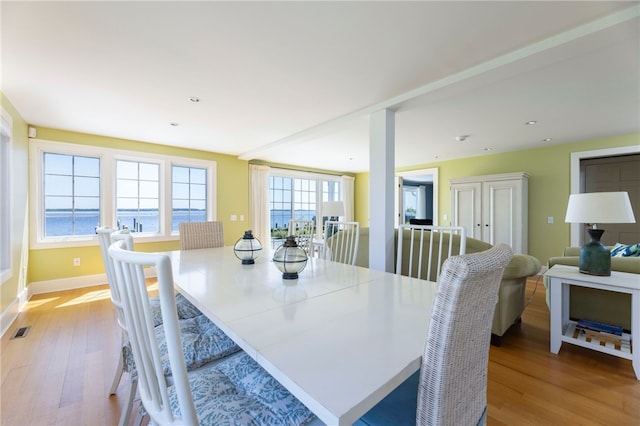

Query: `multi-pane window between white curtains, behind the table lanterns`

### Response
(269, 169, 342, 247)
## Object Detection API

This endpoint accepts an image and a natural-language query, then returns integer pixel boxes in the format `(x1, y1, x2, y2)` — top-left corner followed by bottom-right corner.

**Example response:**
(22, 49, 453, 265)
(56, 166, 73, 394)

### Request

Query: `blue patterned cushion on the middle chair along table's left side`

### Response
(122, 314, 240, 377)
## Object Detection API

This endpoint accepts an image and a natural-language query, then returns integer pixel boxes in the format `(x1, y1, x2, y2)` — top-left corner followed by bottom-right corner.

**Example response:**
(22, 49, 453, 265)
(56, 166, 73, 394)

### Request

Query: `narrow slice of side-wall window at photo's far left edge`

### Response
(0, 109, 13, 283)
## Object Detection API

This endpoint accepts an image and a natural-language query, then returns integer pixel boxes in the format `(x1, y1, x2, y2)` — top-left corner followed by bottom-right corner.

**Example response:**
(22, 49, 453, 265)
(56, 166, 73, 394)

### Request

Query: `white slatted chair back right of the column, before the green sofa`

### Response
(396, 224, 467, 281)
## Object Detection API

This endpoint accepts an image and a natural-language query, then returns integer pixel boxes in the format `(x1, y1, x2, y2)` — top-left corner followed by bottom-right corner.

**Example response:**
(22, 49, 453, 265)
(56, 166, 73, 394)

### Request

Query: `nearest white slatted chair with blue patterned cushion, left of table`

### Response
(109, 241, 316, 425)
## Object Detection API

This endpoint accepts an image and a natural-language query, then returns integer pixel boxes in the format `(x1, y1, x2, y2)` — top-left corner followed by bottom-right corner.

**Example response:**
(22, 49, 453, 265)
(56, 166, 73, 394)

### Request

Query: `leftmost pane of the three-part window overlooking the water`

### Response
(43, 152, 100, 237)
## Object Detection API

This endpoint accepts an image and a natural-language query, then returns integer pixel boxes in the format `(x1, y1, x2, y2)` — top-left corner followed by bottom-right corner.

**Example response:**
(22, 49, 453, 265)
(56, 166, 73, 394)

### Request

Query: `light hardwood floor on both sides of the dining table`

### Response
(0, 279, 640, 426)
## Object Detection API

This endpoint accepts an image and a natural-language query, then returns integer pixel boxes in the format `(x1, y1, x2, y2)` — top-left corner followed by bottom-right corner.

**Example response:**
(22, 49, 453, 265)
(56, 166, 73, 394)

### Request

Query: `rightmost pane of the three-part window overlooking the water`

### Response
(171, 166, 207, 232)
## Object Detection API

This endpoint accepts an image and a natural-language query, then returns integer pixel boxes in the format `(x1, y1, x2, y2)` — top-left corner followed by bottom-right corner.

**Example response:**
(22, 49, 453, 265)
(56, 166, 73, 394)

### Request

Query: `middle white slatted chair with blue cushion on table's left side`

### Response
(96, 227, 240, 426)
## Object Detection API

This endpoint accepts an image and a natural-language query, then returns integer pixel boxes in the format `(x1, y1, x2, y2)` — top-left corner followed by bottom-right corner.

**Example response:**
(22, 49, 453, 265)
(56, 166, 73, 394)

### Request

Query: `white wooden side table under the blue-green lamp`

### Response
(545, 265, 640, 380)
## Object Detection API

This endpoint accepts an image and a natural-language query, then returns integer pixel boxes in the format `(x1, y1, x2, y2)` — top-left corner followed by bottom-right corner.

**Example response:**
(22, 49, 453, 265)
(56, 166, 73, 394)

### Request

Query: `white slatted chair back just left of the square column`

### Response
(323, 220, 360, 265)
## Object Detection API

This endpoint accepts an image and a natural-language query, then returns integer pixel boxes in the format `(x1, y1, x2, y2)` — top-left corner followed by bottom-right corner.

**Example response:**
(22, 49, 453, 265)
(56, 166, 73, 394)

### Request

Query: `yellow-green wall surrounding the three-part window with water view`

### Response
(28, 127, 249, 283)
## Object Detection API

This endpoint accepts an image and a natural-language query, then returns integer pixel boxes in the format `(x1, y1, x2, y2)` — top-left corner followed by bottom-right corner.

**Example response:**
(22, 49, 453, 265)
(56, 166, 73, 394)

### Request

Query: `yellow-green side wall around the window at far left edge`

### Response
(0, 93, 29, 312)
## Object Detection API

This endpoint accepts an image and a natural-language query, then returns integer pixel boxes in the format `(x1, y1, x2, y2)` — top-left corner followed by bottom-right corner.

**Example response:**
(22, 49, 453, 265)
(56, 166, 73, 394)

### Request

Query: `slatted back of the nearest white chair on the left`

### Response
(109, 240, 198, 425)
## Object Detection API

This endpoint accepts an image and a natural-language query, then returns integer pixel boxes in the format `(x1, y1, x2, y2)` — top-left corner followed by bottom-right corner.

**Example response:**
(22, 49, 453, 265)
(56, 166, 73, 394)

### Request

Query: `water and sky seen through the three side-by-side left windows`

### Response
(43, 153, 207, 237)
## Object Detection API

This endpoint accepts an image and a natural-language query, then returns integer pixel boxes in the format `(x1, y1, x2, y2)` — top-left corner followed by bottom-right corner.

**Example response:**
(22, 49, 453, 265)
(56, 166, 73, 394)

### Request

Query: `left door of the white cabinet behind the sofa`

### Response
(451, 182, 482, 240)
